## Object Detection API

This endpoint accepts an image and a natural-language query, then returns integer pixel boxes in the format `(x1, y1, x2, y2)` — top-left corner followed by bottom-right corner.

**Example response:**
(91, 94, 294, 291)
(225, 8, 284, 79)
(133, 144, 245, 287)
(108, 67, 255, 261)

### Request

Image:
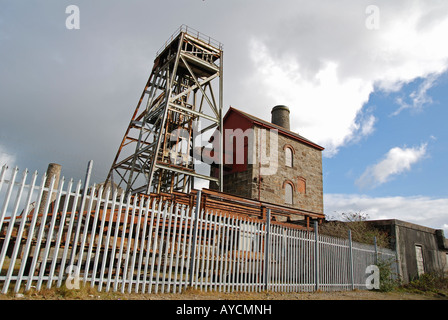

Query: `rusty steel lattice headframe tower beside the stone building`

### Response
(106, 25, 223, 194)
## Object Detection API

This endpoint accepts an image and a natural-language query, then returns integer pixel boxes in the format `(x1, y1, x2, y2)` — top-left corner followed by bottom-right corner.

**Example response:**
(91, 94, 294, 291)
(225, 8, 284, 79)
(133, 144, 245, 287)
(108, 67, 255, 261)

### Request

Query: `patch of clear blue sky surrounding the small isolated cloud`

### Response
(324, 73, 448, 197)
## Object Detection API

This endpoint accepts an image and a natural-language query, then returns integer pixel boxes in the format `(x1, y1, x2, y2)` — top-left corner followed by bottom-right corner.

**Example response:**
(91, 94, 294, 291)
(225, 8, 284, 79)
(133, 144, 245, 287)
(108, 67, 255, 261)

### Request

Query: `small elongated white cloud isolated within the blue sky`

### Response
(356, 144, 427, 188)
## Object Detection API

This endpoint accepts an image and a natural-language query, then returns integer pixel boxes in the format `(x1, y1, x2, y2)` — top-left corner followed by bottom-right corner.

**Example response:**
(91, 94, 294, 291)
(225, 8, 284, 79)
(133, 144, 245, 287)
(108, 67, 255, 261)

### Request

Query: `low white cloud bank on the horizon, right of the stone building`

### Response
(324, 194, 448, 236)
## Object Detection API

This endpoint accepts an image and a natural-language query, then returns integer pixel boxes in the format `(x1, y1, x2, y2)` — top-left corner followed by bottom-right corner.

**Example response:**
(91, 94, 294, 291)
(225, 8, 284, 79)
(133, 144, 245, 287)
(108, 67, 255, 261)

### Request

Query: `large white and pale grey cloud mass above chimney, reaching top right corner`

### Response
(246, 1, 448, 156)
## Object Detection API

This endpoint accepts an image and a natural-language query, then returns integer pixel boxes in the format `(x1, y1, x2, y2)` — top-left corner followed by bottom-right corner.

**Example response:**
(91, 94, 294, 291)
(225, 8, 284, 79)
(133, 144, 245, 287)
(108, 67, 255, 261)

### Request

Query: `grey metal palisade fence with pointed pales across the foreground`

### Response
(0, 166, 395, 293)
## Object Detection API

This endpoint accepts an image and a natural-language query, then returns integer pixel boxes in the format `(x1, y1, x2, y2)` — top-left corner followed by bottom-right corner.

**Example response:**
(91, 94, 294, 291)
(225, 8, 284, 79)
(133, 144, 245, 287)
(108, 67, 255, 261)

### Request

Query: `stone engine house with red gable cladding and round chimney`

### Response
(215, 106, 324, 224)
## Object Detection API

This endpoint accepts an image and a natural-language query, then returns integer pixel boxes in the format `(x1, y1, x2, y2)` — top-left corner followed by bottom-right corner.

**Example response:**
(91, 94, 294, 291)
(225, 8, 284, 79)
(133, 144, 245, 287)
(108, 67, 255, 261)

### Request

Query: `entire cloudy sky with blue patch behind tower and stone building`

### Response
(0, 0, 448, 235)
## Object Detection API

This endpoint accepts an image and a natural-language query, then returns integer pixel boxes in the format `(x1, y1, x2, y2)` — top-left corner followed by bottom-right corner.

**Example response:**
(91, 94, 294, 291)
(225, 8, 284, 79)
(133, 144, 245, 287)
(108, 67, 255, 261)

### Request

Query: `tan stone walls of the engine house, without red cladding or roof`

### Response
(220, 127, 323, 214)
